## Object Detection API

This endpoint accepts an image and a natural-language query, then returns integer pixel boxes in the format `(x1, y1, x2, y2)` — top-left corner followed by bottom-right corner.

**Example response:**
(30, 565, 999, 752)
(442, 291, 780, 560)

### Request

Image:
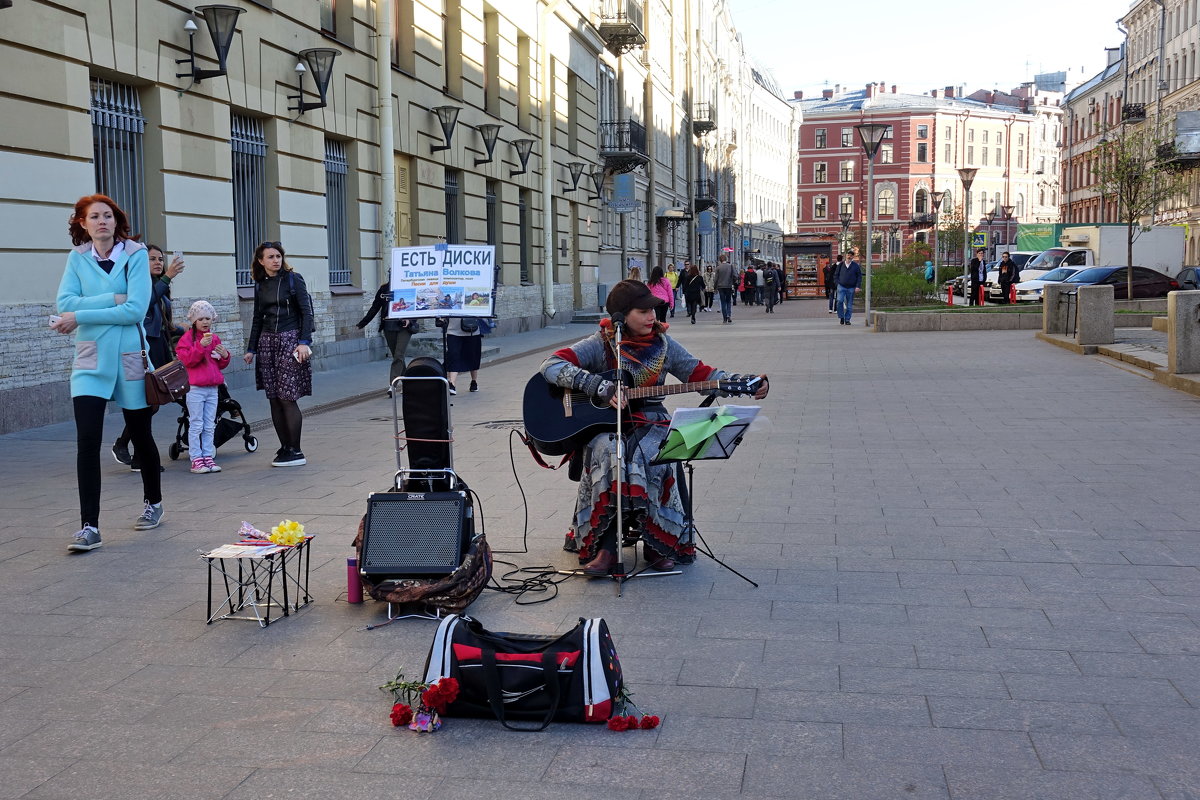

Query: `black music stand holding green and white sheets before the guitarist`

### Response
(652, 405, 760, 589)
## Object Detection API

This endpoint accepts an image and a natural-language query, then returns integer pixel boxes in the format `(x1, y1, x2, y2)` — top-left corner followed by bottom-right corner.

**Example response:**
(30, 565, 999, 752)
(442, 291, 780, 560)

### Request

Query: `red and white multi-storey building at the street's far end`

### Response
(793, 84, 1062, 263)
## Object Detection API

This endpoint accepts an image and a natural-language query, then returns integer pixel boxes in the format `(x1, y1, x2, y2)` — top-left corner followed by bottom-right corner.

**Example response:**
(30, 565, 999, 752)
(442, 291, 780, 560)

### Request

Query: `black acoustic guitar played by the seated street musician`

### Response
(523, 371, 762, 456)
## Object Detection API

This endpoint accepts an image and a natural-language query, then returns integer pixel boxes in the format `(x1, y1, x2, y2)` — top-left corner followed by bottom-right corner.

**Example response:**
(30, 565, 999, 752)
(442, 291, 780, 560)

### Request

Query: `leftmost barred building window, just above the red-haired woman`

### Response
(91, 78, 146, 241)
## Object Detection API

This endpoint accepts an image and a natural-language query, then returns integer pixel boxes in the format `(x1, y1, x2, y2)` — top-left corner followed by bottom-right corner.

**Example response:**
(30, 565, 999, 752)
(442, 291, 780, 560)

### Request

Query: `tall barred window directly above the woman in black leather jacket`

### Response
(229, 114, 266, 287)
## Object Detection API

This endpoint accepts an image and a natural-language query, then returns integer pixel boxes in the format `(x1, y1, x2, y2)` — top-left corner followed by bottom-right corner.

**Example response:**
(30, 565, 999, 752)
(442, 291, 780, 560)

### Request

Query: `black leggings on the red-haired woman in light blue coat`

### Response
(72, 395, 162, 529)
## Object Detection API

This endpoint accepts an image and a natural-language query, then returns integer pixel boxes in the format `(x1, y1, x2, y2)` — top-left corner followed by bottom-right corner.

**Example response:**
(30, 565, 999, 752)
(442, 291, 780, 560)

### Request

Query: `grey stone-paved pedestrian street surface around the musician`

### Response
(0, 297, 1200, 800)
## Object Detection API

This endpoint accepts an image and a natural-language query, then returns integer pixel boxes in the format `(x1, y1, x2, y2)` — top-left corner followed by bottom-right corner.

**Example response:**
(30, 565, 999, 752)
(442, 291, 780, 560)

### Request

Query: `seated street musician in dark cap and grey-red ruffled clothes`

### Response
(541, 281, 769, 577)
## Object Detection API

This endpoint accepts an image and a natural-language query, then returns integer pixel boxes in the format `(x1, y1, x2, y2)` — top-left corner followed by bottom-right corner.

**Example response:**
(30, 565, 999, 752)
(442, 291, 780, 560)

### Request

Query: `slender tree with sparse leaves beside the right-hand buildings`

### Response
(1093, 121, 1186, 300)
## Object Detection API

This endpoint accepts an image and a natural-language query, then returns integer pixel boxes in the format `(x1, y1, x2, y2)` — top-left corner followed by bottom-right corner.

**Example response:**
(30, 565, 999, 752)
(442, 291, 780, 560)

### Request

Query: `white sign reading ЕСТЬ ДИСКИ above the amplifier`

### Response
(388, 245, 496, 319)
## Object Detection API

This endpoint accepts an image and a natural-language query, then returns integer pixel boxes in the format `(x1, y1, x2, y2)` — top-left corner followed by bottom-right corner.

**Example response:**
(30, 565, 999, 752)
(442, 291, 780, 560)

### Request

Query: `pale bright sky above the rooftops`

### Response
(728, 0, 1130, 98)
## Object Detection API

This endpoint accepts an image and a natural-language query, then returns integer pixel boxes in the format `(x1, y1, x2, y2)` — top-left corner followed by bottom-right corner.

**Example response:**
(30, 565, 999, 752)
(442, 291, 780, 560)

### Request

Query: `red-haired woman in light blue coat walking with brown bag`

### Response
(50, 194, 163, 552)
